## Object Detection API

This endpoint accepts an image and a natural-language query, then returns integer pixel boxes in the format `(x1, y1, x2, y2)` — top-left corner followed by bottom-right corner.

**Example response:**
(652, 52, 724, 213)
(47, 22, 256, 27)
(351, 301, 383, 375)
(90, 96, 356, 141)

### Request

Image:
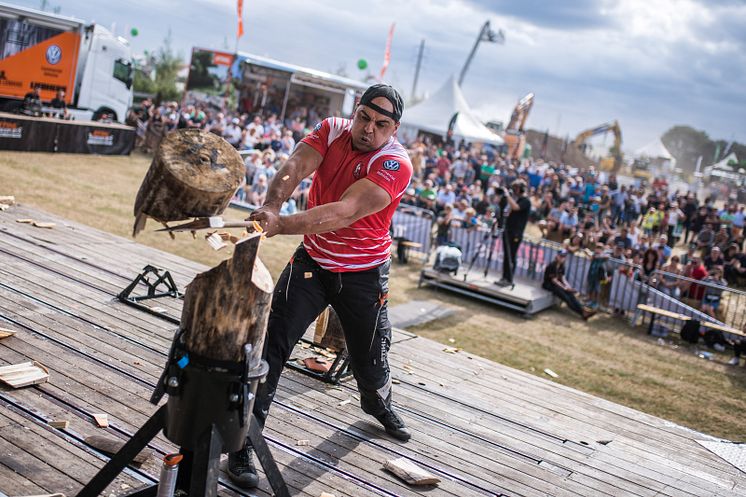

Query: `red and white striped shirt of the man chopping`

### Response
(302, 117, 412, 272)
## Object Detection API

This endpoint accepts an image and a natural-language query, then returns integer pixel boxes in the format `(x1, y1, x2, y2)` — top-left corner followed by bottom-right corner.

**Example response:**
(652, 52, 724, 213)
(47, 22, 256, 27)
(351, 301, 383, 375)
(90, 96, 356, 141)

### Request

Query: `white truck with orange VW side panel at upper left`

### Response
(0, 2, 134, 122)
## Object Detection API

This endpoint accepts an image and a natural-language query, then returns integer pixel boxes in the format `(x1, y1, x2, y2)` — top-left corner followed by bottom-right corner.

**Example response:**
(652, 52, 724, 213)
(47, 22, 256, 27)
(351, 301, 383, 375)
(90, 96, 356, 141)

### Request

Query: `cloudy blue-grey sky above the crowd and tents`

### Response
(13, 0, 746, 151)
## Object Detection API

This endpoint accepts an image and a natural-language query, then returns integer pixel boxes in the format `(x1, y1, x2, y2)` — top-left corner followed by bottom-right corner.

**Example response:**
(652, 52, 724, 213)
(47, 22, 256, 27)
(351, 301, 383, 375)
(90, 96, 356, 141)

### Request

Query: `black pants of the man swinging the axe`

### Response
(254, 246, 391, 427)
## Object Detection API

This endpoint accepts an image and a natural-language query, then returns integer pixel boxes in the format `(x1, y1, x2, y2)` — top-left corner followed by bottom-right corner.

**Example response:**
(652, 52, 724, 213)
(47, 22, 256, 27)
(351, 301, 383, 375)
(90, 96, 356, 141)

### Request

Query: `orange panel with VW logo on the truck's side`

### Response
(0, 32, 80, 104)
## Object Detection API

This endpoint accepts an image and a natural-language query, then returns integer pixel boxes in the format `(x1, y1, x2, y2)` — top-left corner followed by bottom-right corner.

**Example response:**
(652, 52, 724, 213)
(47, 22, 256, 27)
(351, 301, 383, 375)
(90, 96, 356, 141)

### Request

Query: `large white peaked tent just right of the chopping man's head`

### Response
(399, 76, 504, 145)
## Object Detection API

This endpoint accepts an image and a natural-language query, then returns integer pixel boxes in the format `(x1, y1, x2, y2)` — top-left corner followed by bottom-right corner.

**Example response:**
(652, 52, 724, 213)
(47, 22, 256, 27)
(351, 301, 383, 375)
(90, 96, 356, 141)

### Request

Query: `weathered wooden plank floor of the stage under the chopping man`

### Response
(0, 206, 746, 497)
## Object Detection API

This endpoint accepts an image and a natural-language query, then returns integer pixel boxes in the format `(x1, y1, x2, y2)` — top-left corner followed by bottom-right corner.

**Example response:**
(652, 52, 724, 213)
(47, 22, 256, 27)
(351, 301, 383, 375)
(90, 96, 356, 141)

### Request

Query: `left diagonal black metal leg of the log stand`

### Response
(78, 406, 166, 497)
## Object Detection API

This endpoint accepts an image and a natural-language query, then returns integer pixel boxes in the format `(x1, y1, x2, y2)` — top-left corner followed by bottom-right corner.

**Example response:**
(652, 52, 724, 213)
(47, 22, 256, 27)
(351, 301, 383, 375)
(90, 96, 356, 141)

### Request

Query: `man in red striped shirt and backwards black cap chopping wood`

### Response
(228, 84, 412, 488)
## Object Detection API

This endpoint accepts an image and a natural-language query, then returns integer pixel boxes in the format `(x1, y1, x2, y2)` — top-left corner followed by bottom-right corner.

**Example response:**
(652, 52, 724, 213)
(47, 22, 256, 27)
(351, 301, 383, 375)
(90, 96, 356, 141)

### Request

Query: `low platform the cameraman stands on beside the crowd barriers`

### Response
(419, 268, 555, 315)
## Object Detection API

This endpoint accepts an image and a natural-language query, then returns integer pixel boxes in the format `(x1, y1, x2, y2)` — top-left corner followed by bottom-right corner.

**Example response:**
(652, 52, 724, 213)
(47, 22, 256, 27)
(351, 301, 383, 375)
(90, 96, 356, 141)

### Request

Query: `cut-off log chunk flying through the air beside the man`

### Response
(132, 129, 245, 236)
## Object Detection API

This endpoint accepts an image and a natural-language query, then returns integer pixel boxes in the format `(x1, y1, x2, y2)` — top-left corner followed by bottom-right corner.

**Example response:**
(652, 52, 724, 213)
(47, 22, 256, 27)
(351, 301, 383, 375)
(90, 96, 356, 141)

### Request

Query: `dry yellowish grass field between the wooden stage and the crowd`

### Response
(0, 152, 746, 441)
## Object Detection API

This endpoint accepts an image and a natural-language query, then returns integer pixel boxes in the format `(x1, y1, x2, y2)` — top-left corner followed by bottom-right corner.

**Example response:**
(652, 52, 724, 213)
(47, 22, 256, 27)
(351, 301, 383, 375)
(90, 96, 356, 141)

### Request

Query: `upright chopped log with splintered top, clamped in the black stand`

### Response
(181, 233, 274, 368)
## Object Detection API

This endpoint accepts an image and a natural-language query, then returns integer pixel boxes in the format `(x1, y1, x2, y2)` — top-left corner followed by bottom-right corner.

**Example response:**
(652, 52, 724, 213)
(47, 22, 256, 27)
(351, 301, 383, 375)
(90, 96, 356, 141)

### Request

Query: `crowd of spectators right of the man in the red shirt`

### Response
(402, 141, 746, 316)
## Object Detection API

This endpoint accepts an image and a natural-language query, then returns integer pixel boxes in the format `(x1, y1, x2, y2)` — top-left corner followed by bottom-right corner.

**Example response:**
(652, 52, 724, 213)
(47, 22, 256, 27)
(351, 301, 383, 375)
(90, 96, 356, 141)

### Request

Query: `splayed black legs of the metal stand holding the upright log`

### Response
(77, 406, 290, 497)
